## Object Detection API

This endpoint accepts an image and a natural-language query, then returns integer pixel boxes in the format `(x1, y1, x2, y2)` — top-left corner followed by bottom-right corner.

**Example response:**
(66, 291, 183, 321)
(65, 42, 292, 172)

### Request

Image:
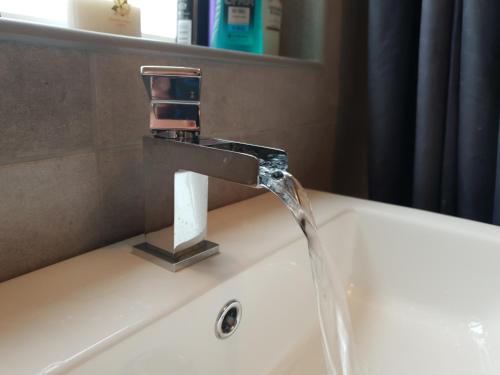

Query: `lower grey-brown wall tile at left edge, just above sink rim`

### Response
(0, 153, 101, 280)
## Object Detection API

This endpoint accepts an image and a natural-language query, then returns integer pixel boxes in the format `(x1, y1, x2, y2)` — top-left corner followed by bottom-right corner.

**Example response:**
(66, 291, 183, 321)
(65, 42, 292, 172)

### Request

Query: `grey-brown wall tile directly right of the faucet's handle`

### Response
(202, 64, 328, 137)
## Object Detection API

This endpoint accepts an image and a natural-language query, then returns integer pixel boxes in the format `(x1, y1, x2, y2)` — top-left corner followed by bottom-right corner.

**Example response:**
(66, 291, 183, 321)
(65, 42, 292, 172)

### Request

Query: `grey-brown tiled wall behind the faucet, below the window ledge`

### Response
(0, 15, 340, 280)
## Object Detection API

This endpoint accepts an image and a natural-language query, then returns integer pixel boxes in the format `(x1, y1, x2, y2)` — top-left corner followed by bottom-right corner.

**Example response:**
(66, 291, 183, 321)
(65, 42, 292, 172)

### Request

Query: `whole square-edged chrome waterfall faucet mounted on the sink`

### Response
(136, 66, 286, 271)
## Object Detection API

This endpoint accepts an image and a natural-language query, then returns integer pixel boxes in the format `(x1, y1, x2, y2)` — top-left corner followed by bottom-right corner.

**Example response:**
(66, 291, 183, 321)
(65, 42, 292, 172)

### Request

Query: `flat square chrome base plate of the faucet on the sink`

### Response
(134, 240, 219, 272)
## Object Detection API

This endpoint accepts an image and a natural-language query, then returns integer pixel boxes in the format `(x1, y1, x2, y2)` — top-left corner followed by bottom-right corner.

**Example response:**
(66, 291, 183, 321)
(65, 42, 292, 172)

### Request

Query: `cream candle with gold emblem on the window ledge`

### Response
(68, 0, 141, 36)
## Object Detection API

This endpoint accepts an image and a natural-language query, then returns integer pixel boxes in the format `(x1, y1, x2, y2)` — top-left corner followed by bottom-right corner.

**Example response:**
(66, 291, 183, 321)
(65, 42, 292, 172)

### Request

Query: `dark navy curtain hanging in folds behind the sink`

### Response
(367, 0, 500, 224)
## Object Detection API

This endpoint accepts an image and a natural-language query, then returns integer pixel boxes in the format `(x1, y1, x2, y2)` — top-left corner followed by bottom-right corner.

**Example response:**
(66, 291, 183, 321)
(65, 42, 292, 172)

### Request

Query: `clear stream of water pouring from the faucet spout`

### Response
(259, 155, 360, 375)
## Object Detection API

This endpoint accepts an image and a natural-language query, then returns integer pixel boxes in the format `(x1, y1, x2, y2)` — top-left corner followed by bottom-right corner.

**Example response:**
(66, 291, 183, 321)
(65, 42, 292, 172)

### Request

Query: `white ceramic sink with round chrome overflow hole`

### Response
(0, 192, 500, 375)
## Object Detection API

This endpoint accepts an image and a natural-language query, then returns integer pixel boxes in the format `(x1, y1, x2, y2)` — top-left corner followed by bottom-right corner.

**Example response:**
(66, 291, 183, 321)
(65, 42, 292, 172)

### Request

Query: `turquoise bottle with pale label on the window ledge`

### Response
(210, 0, 264, 54)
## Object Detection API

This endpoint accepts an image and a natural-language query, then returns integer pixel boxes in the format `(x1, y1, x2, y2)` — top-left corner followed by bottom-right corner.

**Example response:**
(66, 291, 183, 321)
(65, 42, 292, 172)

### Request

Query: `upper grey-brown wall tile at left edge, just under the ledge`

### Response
(0, 42, 93, 164)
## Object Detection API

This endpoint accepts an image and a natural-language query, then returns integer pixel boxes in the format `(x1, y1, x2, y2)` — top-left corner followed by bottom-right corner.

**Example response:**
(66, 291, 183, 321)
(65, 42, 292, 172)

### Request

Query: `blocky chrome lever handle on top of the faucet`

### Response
(141, 66, 201, 138)
